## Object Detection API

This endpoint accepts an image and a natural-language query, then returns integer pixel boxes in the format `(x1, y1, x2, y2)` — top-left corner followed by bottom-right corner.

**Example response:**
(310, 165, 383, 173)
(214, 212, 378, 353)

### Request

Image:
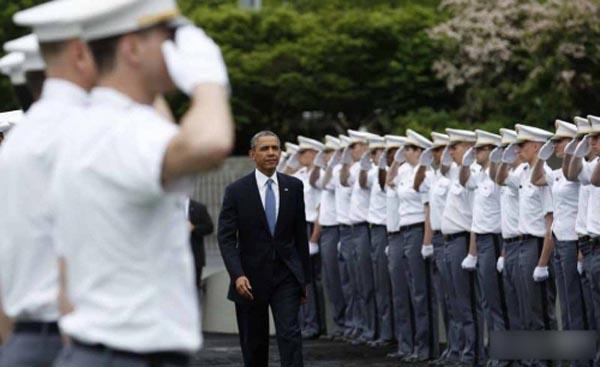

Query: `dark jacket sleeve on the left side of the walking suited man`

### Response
(217, 186, 244, 282)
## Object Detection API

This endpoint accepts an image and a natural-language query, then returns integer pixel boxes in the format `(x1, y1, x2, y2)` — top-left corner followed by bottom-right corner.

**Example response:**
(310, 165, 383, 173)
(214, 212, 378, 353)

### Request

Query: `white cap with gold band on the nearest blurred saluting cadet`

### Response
(82, 0, 189, 41)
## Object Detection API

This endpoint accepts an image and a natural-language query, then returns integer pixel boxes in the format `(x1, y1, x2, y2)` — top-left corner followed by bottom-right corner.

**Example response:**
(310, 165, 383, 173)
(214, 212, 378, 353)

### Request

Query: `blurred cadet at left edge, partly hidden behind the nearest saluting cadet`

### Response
(0, 1, 96, 367)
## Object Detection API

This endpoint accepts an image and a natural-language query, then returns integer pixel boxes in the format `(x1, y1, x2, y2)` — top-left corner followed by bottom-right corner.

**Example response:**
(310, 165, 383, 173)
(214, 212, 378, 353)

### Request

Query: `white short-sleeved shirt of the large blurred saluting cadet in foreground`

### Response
(52, 88, 201, 353)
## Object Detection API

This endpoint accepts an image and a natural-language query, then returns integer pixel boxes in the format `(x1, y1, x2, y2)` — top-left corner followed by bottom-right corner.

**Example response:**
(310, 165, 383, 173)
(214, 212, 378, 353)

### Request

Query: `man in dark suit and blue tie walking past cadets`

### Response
(218, 131, 311, 367)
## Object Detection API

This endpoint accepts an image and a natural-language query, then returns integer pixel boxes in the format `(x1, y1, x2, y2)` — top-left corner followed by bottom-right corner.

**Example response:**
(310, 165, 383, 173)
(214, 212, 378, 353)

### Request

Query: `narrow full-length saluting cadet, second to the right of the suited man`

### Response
(311, 135, 347, 339)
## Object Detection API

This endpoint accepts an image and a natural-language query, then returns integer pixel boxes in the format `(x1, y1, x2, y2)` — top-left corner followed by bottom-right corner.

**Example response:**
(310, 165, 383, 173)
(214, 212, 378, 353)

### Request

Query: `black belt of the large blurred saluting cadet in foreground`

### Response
(73, 340, 190, 367)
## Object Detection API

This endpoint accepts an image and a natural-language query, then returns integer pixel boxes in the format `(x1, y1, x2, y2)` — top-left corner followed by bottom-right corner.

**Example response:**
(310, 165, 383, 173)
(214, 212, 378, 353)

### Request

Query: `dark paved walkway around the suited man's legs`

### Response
(194, 334, 425, 367)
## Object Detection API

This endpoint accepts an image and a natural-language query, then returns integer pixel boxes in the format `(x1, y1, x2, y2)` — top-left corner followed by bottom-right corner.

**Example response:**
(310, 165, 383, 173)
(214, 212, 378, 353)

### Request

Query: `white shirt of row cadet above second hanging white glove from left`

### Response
(396, 163, 428, 227)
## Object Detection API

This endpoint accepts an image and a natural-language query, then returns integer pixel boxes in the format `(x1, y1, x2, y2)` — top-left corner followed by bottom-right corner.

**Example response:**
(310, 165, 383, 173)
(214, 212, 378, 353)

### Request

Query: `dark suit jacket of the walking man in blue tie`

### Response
(218, 171, 311, 303)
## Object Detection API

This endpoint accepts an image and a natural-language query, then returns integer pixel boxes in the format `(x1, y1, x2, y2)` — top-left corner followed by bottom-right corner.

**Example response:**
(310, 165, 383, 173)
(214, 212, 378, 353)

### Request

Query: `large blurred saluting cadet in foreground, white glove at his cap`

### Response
(52, 0, 234, 367)
